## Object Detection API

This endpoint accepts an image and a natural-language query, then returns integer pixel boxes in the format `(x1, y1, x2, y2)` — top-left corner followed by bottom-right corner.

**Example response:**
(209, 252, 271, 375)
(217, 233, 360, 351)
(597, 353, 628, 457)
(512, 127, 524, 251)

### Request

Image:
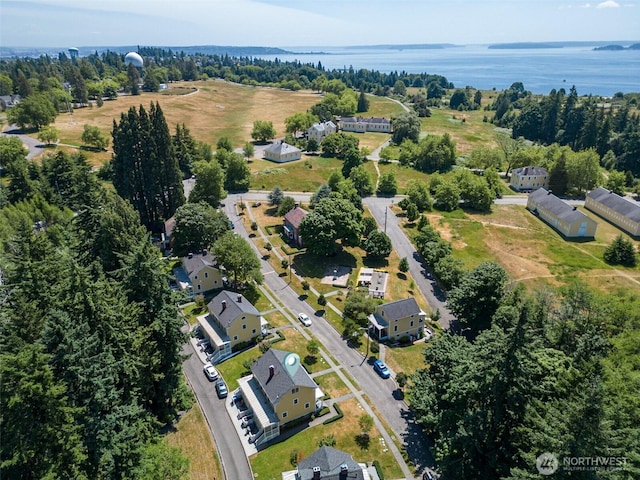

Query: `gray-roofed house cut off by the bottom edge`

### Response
(282, 445, 379, 480)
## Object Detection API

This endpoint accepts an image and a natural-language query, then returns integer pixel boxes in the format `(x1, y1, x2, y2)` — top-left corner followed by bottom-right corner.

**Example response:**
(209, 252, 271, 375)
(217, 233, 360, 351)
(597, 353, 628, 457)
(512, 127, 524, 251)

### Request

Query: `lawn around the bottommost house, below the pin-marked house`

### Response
(249, 399, 402, 480)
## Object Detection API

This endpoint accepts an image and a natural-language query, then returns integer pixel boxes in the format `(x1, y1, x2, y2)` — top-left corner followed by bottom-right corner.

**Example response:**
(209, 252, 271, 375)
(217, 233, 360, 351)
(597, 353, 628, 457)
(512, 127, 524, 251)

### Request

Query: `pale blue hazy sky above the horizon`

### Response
(0, 0, 640, 47)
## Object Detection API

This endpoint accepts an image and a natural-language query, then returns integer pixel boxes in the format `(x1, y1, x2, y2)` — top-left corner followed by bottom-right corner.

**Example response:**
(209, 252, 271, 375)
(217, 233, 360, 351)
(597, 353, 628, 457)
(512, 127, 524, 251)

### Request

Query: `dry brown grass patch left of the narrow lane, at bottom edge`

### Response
(164, 403, 223, 480)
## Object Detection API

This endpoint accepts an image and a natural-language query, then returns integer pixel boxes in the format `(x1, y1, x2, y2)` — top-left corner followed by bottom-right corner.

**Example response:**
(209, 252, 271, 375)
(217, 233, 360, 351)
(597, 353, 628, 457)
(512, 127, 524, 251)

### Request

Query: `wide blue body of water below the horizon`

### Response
(252, 45, 640, 96)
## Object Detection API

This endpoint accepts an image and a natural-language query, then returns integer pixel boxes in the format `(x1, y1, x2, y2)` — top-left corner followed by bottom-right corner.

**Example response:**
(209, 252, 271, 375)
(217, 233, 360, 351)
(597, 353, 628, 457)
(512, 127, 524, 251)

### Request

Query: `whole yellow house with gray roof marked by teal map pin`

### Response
(238, 348, 324, 446)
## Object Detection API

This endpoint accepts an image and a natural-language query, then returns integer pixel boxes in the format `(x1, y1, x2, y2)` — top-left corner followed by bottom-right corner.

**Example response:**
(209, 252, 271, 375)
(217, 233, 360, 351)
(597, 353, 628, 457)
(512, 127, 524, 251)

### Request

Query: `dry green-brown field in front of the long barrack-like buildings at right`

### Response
(407, 205, 640, 292)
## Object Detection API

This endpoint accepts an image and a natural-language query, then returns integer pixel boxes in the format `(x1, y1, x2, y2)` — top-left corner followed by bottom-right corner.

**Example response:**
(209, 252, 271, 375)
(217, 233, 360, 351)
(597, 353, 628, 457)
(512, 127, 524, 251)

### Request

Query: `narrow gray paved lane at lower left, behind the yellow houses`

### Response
(182, 342, 253, 480)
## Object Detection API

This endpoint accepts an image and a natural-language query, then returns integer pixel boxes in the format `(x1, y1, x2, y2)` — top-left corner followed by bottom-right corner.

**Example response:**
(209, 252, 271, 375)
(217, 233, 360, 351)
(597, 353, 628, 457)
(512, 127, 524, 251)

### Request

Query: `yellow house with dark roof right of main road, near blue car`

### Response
(369, 297, 427, 342)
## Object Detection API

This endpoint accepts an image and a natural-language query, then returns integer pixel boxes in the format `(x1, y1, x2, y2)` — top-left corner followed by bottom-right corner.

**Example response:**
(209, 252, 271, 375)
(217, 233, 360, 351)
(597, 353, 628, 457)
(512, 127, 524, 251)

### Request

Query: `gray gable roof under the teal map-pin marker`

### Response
(251, 348, 318, 405)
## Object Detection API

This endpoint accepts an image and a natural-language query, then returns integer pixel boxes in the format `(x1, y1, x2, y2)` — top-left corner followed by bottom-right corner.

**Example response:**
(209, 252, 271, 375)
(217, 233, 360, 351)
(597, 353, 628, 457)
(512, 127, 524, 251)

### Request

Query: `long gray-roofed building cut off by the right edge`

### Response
(584, 187, 640, 239)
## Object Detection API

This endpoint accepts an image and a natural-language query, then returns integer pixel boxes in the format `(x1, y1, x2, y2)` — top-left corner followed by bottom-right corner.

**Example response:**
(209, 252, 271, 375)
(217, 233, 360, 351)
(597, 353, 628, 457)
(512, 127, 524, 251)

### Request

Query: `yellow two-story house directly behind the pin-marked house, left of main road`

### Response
(198, 290, 266, 363)
